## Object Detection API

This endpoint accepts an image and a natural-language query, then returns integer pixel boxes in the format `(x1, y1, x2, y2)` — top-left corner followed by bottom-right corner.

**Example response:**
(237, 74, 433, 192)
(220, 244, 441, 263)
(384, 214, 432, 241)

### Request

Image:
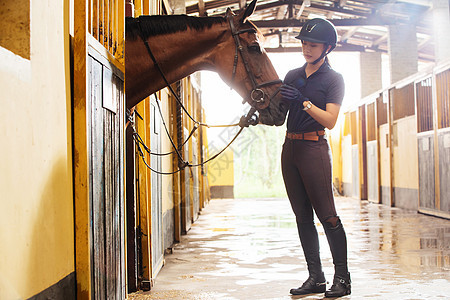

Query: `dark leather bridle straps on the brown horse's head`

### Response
(228, 16, 282, 109)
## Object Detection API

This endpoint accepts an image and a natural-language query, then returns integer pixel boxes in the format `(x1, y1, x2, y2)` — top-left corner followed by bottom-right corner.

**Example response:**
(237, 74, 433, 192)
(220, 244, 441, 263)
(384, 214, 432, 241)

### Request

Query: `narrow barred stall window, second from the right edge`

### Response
(416, 77, 433, 132)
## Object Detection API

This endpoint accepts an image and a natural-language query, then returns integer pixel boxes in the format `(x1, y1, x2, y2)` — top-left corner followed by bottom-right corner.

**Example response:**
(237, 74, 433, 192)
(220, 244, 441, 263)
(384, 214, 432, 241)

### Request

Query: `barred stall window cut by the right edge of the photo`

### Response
(436, 70, 450, 129)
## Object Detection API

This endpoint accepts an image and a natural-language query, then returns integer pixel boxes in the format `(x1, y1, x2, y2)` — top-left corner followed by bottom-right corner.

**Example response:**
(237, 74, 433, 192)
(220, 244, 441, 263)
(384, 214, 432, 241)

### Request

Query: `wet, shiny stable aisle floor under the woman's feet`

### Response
(130, 198, 450, 299)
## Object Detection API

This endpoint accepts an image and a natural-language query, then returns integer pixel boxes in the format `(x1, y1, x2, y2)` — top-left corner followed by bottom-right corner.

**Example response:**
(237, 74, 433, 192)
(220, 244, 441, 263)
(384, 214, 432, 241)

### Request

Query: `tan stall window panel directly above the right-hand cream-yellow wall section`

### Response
(389, 83, 415, 120)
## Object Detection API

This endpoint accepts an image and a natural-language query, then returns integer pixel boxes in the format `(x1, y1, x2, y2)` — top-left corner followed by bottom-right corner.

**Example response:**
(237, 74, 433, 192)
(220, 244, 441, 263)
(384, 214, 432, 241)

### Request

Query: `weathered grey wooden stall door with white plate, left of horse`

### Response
(88, 52, 126, 299)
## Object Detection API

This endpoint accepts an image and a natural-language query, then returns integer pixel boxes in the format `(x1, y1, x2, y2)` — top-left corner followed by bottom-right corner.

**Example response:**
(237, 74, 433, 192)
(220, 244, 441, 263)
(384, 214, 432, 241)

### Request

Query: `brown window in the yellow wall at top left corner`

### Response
(0, 0, 30, 59)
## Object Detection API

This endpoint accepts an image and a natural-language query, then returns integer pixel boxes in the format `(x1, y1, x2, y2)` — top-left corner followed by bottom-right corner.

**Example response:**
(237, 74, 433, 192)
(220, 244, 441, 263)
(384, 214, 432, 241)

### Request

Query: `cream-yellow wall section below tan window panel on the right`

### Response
(394, 116, 419, 189)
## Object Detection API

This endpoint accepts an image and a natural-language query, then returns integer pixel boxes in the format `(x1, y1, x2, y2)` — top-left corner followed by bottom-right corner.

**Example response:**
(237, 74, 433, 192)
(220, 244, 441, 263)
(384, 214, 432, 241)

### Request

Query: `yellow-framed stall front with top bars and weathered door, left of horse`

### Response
(71, 0, 127, 299)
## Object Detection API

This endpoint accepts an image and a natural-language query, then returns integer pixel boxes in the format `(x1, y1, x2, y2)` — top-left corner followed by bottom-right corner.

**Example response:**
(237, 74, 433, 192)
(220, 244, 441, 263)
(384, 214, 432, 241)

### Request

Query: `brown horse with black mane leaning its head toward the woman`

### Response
(125, 0, 287, 125)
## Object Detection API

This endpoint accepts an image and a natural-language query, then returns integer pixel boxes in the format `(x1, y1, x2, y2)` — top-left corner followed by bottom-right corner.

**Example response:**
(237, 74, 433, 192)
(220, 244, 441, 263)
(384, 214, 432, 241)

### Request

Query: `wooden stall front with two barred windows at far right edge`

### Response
(415, 65, 450, 218)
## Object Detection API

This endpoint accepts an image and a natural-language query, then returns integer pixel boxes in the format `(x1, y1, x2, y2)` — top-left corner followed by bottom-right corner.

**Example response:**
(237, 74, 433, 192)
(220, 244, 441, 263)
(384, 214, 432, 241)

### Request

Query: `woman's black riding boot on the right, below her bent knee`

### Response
(323, 219, 351, 297)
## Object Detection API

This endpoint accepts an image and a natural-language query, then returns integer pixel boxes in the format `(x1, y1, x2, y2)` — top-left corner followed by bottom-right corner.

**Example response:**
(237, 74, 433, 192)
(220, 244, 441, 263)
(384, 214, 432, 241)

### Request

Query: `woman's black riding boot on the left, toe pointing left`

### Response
(291, 223, 326, 295)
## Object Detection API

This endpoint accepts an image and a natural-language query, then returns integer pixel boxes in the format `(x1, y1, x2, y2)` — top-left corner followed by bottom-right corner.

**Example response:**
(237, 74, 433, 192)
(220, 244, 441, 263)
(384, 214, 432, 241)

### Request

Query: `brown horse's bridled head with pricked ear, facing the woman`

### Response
(216, 0, 288, 126)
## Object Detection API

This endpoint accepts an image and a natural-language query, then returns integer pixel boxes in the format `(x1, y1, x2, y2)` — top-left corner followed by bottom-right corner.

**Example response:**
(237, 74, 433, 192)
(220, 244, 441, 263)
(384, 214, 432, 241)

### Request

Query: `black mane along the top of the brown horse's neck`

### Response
(125, 15, 226, 39)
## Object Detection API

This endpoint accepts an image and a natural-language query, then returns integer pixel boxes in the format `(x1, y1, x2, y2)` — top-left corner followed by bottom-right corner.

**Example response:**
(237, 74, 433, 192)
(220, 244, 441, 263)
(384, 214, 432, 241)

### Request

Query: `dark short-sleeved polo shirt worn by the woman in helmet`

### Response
(284, 62, 345, 133)
